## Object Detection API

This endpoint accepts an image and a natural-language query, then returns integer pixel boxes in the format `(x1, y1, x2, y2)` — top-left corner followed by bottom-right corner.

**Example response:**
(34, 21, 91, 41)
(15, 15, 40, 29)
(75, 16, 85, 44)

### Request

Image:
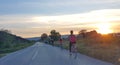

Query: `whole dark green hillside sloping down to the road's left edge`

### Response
(0, 30, 33, 57)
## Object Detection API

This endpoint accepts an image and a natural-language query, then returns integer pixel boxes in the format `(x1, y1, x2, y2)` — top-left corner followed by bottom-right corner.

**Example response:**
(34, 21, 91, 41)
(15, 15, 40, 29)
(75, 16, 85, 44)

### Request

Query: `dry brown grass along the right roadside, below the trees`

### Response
(55, 36, 120, 65)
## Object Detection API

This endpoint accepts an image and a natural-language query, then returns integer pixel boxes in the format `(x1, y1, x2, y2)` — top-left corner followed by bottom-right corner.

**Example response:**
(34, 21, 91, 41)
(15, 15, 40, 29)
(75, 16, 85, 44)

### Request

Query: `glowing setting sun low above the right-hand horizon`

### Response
(97, 23, 113, 34)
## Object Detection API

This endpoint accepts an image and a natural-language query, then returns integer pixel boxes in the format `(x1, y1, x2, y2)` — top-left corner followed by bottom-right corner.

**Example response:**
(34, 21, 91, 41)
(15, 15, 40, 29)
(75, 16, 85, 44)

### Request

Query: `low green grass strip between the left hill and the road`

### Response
(0, 42, 33, 58)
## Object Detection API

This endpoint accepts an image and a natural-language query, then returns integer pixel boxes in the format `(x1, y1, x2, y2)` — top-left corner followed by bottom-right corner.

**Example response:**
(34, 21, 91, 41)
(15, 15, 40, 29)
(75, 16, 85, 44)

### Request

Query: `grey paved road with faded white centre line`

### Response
(0, 42, 113, 65)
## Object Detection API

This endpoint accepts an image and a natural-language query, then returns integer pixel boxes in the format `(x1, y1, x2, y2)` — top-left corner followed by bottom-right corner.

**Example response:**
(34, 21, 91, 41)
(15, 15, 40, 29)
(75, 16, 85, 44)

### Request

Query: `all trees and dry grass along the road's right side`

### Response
(41, 30, 120, 65)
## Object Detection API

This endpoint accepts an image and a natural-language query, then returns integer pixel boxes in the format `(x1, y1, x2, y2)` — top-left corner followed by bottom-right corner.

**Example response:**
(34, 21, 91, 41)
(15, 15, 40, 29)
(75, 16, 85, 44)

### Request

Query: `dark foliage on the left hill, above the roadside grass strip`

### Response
(0, 31, 30, 48)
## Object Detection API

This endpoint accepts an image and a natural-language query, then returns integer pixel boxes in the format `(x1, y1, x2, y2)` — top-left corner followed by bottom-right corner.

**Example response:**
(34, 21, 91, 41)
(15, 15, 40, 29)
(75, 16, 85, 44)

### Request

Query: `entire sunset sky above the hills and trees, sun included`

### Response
(0, 0, 120, 38)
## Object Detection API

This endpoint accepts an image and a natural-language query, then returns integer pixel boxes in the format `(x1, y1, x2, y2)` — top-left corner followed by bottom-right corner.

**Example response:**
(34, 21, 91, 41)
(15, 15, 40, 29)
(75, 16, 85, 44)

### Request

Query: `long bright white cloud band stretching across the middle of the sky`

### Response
(0, 9, 120, 28)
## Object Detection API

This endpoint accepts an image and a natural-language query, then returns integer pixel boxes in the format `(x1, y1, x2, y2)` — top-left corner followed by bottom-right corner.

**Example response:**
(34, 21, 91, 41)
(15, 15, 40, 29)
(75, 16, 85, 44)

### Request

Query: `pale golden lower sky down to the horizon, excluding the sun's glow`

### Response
(0, 9, 120, 37)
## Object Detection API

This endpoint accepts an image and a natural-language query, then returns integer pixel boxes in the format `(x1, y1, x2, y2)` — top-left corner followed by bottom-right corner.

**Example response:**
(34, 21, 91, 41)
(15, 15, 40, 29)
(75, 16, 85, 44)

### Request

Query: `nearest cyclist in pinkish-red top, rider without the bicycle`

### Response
(69, 30, 76, 55)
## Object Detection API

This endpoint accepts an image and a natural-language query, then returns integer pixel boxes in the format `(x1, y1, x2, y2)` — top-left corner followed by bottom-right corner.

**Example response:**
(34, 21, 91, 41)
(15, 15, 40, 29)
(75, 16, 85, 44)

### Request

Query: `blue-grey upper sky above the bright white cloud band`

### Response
(0, 0, 120, 15)
